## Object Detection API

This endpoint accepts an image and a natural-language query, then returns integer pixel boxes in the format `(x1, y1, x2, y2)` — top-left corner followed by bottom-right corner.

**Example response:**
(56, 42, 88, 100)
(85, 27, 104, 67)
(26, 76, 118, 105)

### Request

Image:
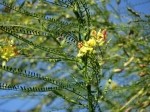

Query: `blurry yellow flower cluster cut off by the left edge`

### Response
(0, 45, 18, 61)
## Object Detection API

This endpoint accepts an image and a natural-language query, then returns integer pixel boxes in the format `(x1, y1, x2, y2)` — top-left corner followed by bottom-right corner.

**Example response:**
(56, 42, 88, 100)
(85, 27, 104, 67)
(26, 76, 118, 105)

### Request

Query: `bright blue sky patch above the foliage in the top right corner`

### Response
(108, 0, 150, 23)
